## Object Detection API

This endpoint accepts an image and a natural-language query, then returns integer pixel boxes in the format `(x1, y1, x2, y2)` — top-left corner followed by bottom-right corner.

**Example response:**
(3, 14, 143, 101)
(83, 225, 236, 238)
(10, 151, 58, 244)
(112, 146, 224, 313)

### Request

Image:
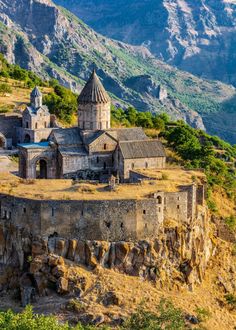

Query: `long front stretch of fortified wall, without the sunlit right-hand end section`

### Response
(0, 196, 163, 241)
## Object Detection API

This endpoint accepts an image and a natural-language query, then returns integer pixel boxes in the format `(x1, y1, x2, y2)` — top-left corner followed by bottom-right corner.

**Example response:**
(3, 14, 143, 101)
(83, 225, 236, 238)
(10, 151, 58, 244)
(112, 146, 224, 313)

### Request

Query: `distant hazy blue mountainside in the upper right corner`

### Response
(55, 0, 236, 85)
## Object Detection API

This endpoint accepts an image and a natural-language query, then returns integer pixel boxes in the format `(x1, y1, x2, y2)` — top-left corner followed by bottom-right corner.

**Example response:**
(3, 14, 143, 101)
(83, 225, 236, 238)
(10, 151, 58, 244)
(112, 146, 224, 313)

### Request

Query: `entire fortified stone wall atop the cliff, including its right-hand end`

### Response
(0, 185, 204, 242)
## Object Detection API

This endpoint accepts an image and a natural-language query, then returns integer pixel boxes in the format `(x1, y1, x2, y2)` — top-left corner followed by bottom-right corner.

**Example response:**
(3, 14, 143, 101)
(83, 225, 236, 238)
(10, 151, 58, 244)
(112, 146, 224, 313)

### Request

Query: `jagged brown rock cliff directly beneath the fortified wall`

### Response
(0, 205, 214, 305)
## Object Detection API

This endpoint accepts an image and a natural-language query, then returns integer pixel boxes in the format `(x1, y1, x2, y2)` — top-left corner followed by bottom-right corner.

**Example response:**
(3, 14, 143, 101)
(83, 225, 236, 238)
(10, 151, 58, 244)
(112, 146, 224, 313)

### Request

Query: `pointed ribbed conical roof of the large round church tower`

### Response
(79, 70, 110, 103)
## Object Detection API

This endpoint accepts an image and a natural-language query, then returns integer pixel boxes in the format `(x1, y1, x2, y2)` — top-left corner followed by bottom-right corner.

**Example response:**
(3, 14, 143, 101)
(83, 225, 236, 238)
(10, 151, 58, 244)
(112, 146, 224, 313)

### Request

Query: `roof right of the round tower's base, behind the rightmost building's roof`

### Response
(106, 127, 147, 141)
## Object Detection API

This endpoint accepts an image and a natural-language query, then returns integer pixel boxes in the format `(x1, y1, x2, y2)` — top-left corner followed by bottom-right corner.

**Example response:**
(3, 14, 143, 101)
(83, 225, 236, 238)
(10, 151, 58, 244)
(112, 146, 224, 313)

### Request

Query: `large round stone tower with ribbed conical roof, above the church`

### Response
(78, 70, 111, 131)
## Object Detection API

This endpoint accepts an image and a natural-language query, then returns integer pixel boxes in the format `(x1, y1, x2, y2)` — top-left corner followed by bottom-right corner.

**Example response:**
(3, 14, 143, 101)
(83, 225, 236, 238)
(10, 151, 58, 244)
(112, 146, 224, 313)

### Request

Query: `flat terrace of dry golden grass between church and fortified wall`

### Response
(0, 169, 205, 200)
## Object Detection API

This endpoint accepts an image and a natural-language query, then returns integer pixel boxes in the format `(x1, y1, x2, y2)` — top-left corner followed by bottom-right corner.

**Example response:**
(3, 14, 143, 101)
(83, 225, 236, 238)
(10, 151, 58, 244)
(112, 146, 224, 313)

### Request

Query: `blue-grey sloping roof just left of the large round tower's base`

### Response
(52, 127, 82, 146)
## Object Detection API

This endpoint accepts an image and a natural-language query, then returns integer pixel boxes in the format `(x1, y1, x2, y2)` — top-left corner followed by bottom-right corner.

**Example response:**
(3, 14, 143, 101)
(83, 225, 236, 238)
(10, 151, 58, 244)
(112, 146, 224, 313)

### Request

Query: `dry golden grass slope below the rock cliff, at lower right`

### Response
(38, 242, 236, 330)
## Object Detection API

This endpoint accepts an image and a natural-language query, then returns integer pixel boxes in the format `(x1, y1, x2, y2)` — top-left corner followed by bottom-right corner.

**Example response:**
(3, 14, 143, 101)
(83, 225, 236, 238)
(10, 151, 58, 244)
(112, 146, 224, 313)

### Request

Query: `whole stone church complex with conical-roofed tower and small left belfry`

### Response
(18, 71, 166, 181)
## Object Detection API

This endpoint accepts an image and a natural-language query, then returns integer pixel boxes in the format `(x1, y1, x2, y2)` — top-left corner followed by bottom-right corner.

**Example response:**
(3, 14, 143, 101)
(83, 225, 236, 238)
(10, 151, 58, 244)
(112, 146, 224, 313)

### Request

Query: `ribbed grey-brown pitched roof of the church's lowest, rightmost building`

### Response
(119, 140, 166, 159)
